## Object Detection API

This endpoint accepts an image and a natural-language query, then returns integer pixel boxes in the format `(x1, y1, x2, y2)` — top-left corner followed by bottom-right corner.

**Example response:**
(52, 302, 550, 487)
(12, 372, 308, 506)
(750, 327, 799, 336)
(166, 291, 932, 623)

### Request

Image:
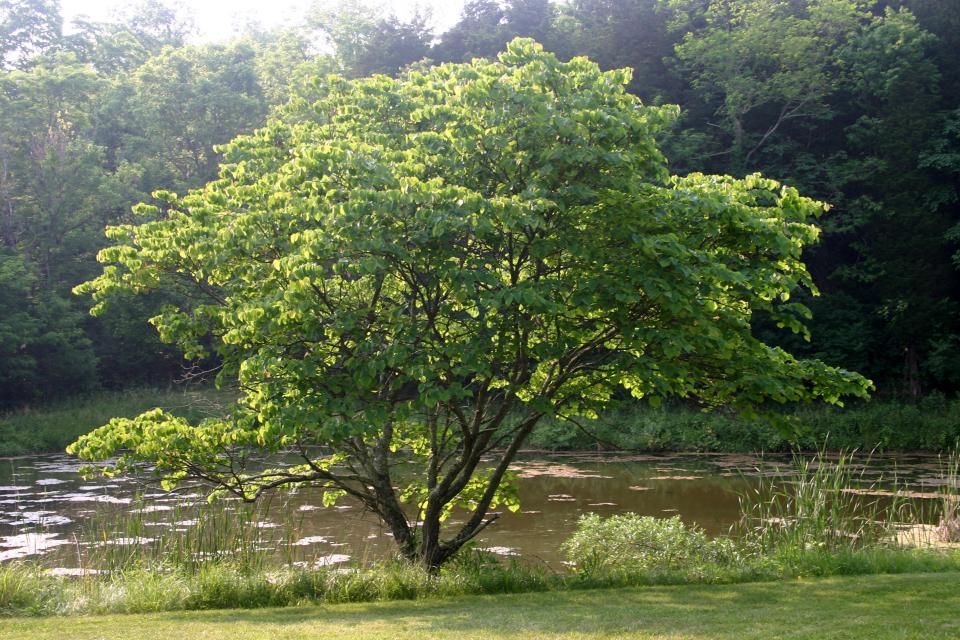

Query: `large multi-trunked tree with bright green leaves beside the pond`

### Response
(70, 39, 869, 568)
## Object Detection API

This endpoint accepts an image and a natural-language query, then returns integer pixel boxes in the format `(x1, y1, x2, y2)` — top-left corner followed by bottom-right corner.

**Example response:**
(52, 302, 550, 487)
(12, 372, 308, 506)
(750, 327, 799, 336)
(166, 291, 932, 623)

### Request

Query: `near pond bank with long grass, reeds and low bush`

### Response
(0, 444, 960, 616)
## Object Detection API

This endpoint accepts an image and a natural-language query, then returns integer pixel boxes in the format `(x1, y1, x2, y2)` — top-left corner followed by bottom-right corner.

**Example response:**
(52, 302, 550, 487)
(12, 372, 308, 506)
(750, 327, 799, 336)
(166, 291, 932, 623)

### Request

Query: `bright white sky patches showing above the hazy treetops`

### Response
(60, 0, 463, 42)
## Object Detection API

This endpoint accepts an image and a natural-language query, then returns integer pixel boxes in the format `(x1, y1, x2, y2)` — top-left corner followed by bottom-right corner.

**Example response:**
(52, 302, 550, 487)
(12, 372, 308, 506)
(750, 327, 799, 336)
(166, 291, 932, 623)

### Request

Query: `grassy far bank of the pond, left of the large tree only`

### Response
(0, 387, 231, 456)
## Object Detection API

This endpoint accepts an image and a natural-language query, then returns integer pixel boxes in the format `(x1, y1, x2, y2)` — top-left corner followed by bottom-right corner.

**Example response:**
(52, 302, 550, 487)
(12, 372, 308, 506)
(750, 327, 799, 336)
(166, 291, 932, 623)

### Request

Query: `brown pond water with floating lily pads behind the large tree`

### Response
(0, 453, 942, 567)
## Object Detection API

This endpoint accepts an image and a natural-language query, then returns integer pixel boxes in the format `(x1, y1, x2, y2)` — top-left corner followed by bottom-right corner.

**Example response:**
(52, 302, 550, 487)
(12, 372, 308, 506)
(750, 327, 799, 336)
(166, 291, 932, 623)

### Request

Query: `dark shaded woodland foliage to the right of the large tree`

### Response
(673, 0, 958, 401)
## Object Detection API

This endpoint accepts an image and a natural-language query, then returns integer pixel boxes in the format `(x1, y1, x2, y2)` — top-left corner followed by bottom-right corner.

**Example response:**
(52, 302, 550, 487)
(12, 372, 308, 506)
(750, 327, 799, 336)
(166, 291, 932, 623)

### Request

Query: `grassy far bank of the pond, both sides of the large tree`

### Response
(0, 388, 960, 456)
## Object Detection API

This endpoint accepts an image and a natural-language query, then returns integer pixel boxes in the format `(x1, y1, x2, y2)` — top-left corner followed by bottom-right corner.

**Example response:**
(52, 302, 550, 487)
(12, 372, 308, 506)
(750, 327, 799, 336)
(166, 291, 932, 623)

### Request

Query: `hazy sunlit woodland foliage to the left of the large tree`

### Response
(0, 6, 328, 409)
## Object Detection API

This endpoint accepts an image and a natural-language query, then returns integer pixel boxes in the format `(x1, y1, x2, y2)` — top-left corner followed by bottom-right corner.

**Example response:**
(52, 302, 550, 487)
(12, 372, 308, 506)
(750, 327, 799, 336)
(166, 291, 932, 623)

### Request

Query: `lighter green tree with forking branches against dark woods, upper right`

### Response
(672, 0, 869, 174)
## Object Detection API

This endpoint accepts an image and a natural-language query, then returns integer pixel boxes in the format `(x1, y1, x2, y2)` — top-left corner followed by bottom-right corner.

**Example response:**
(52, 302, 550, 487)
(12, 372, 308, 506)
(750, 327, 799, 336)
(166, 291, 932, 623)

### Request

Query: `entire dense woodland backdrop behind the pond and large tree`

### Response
(0, 0, 960, 408)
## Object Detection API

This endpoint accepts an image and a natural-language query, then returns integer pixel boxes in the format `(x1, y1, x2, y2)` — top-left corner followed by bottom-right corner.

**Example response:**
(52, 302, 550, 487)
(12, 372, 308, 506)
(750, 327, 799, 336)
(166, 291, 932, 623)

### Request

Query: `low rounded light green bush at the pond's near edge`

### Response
(563, 513, 737, 575)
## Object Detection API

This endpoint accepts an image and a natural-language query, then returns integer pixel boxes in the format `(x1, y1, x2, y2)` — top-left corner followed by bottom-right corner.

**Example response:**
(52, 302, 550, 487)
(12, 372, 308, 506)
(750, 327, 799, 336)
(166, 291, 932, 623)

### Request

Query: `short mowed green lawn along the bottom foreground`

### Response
(0, 573, 960, 640)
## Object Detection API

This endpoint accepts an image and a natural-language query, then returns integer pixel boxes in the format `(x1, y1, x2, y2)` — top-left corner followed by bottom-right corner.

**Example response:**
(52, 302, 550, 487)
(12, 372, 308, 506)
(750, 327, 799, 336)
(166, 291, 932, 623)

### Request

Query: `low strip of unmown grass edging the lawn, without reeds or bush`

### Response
(0, 547, 960, 616)
